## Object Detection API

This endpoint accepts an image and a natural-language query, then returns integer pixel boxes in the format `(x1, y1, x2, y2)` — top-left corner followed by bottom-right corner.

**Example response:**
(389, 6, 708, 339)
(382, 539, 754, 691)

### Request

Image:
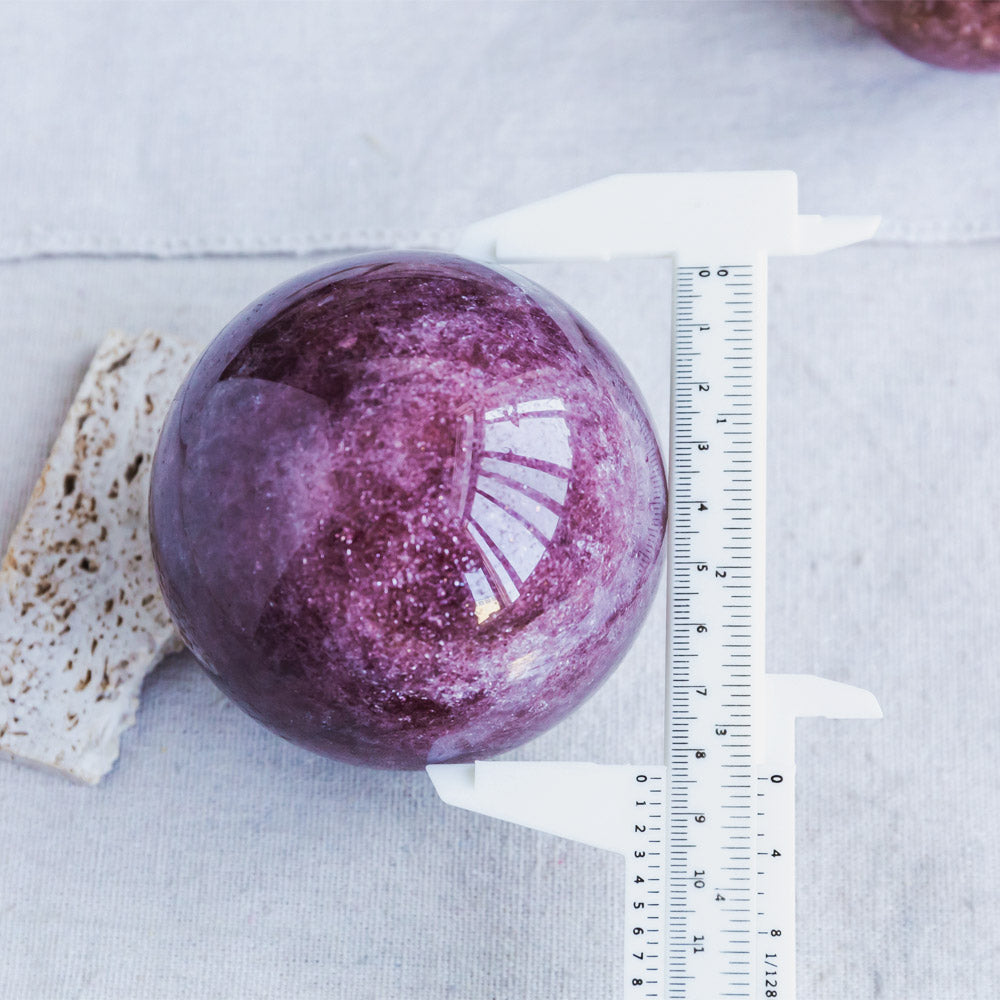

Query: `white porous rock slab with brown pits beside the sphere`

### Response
(0, 333, 197, 784)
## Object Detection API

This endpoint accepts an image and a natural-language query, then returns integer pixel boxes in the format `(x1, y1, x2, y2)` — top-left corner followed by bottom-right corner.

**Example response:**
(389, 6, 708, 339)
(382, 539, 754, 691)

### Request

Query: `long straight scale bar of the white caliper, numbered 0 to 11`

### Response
(666, 255, 767, 1000)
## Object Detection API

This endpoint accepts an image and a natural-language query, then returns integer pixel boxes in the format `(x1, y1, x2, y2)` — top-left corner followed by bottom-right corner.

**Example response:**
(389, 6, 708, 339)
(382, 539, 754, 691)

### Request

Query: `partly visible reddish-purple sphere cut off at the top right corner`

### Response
(850, 0, 1000, 71)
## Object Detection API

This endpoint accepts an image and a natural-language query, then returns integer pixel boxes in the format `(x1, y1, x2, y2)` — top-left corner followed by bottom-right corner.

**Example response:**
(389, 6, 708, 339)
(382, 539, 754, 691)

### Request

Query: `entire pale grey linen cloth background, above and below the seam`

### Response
(0, 0, 1000, 1000)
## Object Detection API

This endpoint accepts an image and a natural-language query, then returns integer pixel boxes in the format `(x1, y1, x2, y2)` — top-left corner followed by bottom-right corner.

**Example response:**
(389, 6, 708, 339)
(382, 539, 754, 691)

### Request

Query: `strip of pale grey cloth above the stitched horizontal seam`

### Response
(0, 0, 1000, 258)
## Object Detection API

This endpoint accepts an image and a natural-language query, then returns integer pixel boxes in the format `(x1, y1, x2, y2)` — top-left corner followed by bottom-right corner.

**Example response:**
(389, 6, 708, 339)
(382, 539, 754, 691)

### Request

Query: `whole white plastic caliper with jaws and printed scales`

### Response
(428, 172, 881, 1000)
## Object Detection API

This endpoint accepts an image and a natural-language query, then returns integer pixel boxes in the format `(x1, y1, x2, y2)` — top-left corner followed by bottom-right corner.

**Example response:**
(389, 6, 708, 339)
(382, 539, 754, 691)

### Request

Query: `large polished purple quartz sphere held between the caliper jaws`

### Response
(150, 252, 666, 768)
